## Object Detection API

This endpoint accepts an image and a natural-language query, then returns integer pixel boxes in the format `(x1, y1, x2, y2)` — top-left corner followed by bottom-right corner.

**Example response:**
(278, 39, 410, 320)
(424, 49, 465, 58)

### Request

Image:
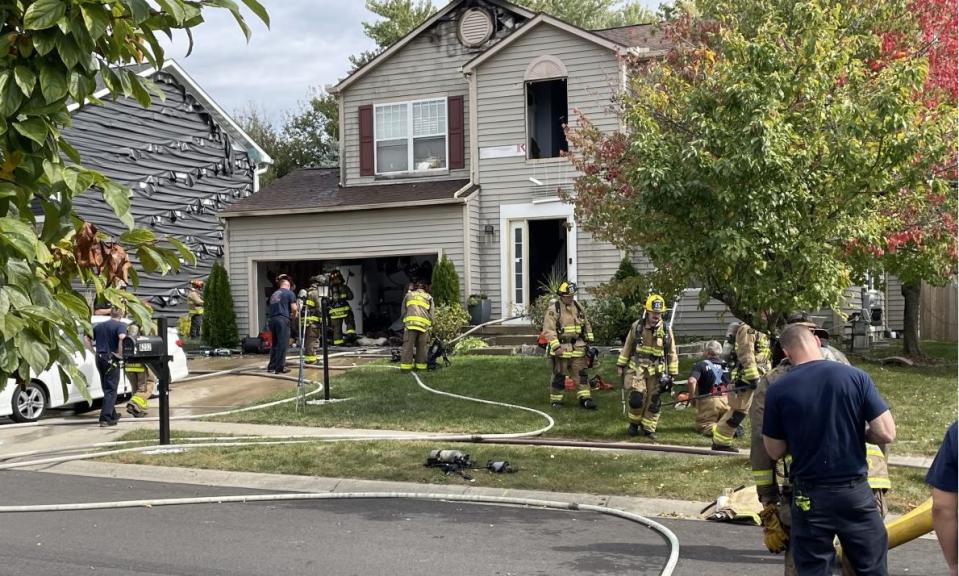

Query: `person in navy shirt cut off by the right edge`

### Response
(926, 422, 959, 576)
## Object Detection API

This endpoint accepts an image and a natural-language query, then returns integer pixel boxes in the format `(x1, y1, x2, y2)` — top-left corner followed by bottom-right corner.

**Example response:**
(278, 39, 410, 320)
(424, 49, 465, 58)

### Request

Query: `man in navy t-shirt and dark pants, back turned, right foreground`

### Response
(763, 325, 896, 576)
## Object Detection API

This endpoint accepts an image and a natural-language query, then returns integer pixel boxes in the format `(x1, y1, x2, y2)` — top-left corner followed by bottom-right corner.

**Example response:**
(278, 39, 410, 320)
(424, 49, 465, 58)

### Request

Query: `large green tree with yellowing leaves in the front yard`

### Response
(568, 0, 956, 329)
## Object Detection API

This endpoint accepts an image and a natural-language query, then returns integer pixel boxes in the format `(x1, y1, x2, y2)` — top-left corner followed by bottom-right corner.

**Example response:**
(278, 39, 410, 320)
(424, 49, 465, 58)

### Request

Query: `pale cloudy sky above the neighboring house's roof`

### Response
(166, 0, 659, 127)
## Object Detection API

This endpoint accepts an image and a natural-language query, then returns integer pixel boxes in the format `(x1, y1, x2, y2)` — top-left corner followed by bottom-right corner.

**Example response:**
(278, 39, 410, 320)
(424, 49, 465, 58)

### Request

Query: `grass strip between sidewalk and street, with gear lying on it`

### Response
(109, 432, 929, 512)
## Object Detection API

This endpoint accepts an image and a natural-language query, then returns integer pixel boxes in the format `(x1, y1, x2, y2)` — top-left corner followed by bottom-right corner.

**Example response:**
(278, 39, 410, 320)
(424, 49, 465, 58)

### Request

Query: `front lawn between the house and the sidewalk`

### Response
(214, 343, 957, 455)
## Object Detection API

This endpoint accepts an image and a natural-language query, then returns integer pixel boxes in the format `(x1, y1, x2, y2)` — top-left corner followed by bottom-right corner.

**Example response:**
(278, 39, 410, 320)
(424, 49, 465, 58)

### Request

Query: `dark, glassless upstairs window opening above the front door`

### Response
(526, 78, 569, 159)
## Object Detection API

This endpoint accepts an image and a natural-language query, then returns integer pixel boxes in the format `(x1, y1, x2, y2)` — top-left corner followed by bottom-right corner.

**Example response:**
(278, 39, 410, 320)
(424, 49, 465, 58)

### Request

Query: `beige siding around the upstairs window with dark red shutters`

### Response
(341, 11, 492, 186)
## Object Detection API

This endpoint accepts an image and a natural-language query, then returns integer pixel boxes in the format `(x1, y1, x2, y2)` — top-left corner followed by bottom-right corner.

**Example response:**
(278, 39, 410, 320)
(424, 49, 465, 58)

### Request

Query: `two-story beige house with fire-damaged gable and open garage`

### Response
(220, 0, 900, 342)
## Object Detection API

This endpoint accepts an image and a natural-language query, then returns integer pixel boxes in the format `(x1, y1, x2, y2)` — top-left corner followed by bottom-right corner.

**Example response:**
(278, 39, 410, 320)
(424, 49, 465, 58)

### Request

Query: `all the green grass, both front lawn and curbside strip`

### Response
(103, 343, 957, 512)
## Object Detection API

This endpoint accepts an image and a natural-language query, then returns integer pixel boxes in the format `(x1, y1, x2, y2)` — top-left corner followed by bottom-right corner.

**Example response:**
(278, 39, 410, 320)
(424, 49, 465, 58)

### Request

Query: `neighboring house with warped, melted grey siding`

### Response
(59, 61, 272, 316)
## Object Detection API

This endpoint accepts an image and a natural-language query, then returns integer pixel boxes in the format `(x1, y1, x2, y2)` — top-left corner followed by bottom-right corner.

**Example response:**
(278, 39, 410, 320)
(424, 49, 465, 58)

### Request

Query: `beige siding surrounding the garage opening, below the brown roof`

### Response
(227, 204, 464, 335)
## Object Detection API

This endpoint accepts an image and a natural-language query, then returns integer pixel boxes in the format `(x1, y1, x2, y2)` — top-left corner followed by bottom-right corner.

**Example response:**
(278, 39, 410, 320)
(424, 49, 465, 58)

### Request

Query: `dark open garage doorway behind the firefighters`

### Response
(251, 254, 437, 338)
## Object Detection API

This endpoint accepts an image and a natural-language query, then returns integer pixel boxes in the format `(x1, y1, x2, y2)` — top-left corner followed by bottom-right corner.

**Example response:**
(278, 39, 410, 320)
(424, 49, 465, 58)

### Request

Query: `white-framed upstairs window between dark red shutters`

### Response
(373, 99, 448, 174)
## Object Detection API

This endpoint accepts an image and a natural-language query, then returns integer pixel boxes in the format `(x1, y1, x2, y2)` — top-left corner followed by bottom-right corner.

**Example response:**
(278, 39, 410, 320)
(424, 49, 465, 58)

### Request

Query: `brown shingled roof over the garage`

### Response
(220, 168, 479, 218)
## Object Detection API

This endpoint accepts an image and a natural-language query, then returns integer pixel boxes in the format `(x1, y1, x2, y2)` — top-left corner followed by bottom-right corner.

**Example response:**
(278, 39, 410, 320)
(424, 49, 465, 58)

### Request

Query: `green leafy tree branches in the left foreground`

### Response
(0, 0, 268, 389)
